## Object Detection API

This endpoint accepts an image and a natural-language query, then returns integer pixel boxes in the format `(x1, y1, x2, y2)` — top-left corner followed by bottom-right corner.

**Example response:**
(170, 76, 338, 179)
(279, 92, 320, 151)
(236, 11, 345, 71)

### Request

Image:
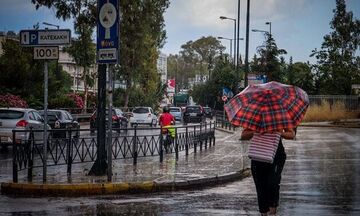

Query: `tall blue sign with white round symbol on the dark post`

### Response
(96, 0, 120, 64)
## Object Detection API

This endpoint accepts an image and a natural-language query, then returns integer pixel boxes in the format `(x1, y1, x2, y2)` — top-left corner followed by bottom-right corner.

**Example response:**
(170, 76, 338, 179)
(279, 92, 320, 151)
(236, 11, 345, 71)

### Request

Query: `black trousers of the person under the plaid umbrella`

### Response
(251, 140, 286, 213)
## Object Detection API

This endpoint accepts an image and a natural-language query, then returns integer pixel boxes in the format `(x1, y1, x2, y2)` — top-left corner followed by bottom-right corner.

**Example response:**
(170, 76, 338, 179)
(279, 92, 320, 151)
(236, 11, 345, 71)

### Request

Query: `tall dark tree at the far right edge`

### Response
(311, 0, 360, 94)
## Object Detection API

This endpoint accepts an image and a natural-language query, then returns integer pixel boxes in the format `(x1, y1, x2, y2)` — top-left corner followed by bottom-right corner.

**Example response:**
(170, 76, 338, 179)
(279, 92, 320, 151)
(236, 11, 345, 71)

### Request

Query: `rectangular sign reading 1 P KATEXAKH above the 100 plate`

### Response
(20, 29, 71, 46)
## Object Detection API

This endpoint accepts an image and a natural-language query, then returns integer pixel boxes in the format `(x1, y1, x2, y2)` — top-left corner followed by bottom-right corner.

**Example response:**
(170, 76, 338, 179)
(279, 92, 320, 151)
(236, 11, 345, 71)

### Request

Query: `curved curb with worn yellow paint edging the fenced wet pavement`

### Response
(1, 169, 251, 197)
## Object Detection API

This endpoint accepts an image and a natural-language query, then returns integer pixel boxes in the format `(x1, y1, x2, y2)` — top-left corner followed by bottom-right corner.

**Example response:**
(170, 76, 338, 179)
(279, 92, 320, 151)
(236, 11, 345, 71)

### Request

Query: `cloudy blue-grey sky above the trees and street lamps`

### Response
(0, 0, 360, 63)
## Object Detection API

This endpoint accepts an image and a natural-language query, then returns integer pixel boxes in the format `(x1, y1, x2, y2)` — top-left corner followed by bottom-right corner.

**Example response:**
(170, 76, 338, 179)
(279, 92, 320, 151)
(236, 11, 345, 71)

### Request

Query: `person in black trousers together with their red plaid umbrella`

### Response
(224, 82, 309, 215)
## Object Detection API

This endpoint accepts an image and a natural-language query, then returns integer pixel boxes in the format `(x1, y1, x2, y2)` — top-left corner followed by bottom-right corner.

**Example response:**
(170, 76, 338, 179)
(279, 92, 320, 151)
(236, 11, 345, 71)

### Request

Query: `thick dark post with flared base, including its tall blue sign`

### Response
(89, 0, 120, 176)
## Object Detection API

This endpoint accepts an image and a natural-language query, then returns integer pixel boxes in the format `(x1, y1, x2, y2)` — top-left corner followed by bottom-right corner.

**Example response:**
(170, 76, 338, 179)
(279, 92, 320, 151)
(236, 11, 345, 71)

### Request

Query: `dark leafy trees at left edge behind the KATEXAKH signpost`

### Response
(0, 39, 72, 108)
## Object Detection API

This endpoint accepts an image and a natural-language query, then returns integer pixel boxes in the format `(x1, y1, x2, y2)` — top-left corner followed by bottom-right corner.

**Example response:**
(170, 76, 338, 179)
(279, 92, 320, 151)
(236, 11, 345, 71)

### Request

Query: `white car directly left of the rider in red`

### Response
(130, 107, 158, 127)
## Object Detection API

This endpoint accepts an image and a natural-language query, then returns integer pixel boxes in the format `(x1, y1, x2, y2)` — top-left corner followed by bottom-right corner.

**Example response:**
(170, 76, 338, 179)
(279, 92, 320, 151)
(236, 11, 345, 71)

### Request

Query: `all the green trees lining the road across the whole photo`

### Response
(0, 0, 360, 108)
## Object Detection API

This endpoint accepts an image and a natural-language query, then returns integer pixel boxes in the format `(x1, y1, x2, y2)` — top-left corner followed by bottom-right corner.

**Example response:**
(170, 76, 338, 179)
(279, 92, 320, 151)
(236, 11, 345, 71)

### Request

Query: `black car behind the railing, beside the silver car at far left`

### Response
(39, 109, 80, 138)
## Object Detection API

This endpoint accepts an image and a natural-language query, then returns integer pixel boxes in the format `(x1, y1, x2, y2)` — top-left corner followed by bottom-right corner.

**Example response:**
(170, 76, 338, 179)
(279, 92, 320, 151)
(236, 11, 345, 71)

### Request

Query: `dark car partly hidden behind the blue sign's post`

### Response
(90, 108, 129, 133)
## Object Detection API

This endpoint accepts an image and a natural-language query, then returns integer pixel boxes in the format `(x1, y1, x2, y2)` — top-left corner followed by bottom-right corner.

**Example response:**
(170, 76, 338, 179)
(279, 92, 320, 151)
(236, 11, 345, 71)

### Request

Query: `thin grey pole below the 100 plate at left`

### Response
(43, 61, 48, 182)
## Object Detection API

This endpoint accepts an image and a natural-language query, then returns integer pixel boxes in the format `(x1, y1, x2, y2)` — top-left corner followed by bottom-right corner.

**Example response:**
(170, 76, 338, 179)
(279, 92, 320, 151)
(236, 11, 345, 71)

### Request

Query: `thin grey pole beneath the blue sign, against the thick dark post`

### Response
(106, 64, 112, 182)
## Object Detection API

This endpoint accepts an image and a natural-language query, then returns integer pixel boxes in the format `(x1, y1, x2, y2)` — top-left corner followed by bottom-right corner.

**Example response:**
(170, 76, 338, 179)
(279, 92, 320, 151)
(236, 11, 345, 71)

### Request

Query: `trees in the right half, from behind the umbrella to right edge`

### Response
(168, 0, 360, 108)
